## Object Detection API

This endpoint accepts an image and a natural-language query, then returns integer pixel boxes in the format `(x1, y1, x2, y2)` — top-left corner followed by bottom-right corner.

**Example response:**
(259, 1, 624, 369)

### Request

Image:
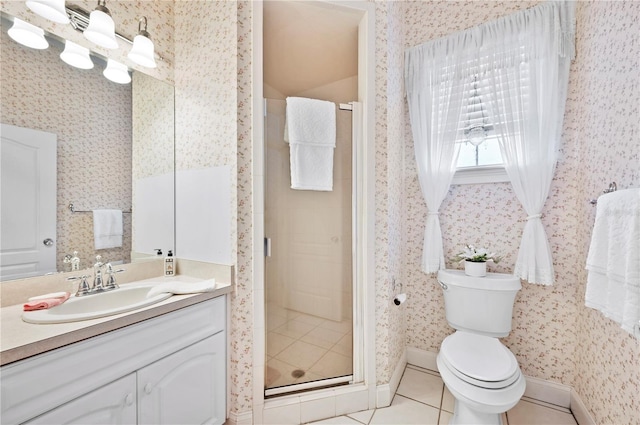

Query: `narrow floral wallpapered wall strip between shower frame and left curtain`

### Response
(375, 1, 407, 384)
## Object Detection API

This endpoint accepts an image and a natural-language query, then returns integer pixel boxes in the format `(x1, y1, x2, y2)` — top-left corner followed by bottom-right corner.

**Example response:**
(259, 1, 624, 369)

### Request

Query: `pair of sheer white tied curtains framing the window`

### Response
(405, 1, 575, 284)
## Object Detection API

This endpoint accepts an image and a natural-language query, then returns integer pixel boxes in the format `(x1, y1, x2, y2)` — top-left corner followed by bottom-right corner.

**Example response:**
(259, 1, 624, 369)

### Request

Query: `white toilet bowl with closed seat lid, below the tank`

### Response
(436, 331, 526, 425)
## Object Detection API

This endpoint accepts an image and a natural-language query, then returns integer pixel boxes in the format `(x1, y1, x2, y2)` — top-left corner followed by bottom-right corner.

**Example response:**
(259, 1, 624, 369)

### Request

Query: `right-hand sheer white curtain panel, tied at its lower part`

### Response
(486, 2, 575, 285)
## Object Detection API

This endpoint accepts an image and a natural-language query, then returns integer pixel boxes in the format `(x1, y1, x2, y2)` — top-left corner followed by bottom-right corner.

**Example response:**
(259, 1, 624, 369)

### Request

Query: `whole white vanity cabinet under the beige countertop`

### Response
(0, 296, 227, 425)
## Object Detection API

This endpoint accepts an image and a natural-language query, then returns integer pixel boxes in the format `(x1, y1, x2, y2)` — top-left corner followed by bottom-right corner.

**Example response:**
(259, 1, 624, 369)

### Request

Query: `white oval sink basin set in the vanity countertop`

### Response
(22, 284, 173, 323)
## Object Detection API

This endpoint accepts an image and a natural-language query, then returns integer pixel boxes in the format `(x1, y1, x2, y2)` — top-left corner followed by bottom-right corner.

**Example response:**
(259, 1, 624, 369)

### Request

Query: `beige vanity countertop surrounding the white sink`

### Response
(0, 275, 232, 365)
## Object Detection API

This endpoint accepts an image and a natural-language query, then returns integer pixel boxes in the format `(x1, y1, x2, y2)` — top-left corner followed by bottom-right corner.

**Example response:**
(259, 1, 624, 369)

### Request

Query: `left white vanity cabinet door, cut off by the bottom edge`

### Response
(26, 373, 136, 425)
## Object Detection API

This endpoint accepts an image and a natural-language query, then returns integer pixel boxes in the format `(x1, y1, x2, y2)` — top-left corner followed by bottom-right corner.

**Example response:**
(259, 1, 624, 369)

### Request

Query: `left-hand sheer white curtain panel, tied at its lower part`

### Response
(405, 52, 463, 273)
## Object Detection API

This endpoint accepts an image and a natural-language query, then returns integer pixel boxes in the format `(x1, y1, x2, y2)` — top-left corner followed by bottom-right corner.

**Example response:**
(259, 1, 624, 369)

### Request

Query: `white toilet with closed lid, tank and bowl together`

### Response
(436, 270, 526, 425)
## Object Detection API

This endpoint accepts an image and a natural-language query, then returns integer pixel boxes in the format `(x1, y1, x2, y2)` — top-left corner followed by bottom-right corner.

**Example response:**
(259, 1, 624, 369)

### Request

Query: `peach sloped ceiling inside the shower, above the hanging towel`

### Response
(263, 1, 361, 96)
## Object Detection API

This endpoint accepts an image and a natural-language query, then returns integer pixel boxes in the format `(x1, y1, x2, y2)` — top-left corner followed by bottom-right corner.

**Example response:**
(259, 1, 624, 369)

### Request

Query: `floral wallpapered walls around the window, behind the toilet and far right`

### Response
(404, 1, 640, 424)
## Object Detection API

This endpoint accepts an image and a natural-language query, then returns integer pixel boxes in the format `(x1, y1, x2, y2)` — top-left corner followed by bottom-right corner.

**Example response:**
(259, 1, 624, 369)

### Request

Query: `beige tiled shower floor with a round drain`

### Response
(265, 303, 353, 388)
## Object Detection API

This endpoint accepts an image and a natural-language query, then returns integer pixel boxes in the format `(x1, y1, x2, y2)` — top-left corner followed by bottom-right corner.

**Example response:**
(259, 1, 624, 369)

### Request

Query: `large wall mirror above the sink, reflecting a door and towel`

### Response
(0, 15, 175, 281)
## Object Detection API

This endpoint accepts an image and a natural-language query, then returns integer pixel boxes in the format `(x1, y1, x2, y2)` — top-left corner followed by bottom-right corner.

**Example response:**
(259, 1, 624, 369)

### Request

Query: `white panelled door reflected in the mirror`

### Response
(0, 124, 58, 280)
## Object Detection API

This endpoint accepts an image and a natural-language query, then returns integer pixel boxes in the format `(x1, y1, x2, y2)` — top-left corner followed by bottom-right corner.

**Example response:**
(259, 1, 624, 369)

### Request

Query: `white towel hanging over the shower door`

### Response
(285, 97, 336, 191)
